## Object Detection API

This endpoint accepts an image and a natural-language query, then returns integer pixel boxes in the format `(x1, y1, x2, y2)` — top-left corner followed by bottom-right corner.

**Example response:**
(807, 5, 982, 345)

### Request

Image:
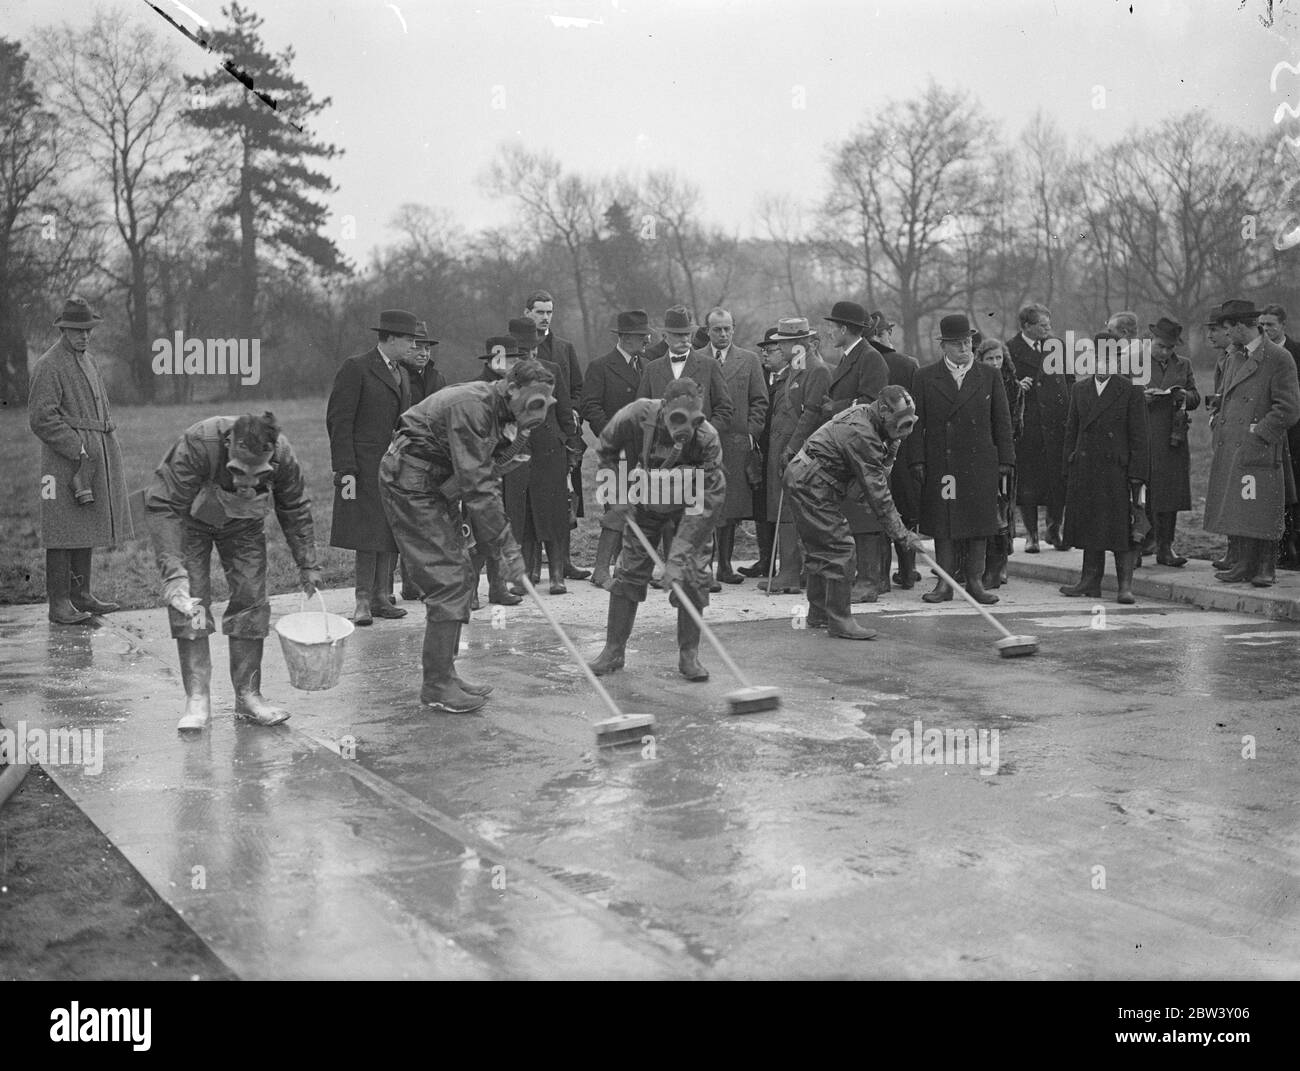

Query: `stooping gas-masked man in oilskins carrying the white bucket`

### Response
(144, 413, 320, 730)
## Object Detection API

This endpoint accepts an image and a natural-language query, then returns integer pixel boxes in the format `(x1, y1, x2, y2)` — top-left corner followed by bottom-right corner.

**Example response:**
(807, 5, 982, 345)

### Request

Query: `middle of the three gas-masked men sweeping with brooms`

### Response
(592, 376, 727, 681)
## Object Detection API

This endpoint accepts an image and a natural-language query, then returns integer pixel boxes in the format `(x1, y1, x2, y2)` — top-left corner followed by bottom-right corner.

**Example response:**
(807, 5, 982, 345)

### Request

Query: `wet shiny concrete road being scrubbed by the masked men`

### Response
(0, 581, 1300, 977)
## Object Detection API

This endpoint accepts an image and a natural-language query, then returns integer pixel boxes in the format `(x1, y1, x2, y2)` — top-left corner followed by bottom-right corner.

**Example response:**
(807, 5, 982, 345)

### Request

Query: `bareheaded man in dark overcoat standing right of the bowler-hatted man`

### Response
(1006, 304, 1074, 554)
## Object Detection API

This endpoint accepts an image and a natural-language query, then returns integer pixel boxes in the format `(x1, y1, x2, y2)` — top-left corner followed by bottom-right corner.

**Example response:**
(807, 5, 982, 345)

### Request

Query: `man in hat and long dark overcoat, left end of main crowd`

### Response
(325, 309, 420, 625)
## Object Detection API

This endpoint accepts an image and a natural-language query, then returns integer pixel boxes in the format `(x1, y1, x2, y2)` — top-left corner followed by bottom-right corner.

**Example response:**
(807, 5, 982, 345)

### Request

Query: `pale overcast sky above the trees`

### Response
(0, 0, 1300, 260)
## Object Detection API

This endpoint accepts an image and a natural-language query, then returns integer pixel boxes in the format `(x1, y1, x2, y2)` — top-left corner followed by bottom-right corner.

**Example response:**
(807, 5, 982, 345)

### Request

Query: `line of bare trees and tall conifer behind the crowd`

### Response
(0, 3, 1300, 404)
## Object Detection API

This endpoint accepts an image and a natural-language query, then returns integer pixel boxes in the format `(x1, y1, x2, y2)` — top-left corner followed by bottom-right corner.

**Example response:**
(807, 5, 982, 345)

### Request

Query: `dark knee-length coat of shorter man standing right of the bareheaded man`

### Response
(1060, 376, 1149, 552)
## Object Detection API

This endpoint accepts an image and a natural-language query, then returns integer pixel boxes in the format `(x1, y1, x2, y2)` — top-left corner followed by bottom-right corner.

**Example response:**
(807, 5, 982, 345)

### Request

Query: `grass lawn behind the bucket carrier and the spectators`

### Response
(0, 396, 1225, 608)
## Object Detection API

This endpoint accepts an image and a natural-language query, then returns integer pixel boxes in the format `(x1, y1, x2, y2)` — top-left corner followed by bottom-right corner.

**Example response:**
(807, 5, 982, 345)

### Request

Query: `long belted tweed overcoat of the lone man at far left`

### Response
(27, 337, 134, 550)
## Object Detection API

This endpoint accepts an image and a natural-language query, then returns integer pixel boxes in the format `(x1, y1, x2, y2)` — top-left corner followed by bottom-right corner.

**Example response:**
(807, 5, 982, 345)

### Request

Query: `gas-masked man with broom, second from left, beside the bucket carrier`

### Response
(380, 356, 555, 714)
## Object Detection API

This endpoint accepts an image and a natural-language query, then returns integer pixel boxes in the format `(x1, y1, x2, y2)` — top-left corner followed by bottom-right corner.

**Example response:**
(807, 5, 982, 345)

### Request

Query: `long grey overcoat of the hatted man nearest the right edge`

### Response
(1204, 338, 1300, 539)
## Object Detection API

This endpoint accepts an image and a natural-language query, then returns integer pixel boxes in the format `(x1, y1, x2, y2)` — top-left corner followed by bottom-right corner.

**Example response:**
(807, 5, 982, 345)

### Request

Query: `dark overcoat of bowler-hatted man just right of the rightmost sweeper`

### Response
(904, 361, 1015, 539)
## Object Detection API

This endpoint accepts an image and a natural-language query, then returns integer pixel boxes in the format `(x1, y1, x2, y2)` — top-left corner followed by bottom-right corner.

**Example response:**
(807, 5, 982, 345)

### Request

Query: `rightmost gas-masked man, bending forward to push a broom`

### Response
(783, 385, 923, 639)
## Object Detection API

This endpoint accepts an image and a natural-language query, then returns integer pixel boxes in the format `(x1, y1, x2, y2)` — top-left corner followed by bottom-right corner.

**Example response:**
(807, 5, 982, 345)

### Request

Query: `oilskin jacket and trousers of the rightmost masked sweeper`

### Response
(784, 406, 907, 581)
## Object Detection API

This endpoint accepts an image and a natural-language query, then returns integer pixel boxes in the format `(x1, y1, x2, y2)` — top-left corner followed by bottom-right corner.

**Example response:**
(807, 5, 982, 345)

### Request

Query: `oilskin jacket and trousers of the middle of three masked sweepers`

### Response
(597, 398, 727, 608)
